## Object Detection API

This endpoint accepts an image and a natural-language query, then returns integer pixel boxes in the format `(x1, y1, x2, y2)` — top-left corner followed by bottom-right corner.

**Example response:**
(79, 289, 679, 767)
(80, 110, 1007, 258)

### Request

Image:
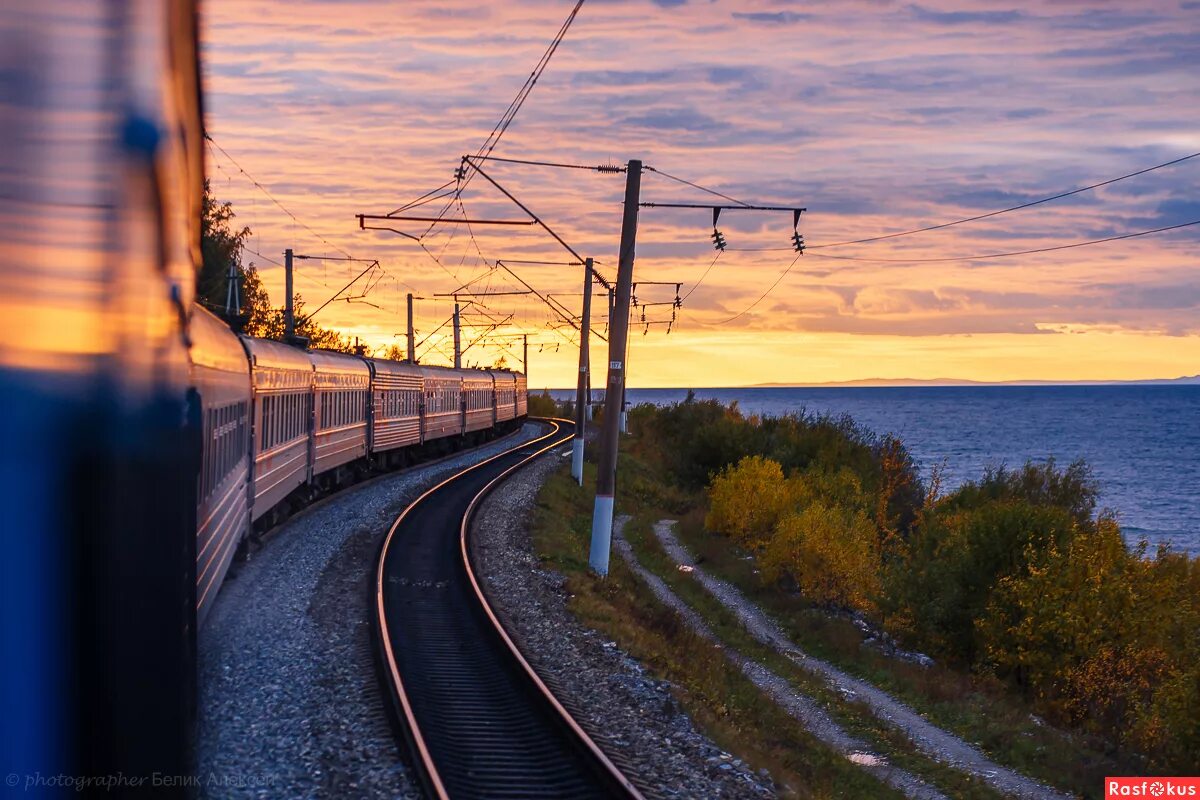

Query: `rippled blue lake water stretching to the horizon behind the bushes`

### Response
(552, 385, 1200, 555)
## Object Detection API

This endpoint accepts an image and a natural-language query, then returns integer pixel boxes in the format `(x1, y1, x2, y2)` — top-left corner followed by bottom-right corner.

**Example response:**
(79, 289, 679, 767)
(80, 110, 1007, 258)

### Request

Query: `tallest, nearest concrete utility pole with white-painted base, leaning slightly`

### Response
(588, 158, 642, 576)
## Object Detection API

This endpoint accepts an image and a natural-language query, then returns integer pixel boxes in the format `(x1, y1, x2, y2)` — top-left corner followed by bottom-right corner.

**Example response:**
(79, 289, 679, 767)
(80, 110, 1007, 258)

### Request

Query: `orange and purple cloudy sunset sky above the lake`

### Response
(203, 0, 1200, 387)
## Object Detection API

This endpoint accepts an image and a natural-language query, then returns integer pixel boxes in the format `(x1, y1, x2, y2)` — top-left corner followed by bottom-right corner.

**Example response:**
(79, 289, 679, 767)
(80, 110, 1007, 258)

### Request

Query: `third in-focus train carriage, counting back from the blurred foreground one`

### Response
(308, 350, 371, 476)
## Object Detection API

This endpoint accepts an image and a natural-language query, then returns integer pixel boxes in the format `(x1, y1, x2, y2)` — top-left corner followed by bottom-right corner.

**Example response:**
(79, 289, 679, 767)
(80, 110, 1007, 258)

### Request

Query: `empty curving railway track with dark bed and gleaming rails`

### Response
(376, 420, 641, 800)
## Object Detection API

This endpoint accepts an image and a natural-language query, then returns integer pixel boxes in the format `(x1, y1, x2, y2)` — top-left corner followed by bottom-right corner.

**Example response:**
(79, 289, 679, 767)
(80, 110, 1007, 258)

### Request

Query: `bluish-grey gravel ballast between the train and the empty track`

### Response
(197, 425, 544, 800)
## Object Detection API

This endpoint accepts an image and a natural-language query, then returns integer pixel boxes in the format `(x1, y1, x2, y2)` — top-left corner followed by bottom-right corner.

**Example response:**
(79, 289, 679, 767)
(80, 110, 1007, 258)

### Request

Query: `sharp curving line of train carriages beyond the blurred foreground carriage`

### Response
(190, 306, 529, 624)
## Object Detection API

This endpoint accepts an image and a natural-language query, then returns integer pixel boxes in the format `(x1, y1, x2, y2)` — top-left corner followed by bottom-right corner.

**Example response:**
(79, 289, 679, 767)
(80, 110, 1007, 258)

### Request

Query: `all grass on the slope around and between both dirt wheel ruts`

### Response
(535, 419, 1138, 798)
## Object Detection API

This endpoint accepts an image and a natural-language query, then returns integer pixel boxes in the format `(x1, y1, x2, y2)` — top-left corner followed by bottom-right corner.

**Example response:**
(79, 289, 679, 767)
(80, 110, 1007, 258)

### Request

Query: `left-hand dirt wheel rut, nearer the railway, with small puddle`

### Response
(613, 516, 948, 800)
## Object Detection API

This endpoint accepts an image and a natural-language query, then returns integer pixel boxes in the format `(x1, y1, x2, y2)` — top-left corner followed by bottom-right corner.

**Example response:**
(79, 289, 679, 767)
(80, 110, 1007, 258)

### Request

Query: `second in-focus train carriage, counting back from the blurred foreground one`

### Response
(241, 337, 313, 521)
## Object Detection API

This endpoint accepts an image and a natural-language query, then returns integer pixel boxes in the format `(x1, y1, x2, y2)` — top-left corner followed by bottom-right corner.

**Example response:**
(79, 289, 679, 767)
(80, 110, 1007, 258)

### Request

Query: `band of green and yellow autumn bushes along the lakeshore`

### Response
(618, 396, 1200, 771)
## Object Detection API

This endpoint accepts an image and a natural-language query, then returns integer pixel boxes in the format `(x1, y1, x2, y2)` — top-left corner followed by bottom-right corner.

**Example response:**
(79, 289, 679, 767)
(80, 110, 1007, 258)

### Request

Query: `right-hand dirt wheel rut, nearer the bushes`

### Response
(654, 519, 1072, 800)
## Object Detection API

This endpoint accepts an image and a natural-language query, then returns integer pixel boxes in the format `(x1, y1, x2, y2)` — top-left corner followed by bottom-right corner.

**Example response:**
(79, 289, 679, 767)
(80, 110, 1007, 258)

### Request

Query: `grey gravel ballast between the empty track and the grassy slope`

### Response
(472, 447, 774, 798)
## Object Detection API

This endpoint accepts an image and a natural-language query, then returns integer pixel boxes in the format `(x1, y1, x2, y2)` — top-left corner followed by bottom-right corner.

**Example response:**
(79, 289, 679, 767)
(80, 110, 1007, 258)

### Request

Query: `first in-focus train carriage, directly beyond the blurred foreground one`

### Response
(190, 306, 251, 620)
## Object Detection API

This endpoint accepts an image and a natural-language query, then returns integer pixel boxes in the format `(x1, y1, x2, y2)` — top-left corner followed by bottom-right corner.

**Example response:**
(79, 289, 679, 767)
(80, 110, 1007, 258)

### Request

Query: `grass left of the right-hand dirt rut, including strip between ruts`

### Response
(534, 462, 1000, 800)
